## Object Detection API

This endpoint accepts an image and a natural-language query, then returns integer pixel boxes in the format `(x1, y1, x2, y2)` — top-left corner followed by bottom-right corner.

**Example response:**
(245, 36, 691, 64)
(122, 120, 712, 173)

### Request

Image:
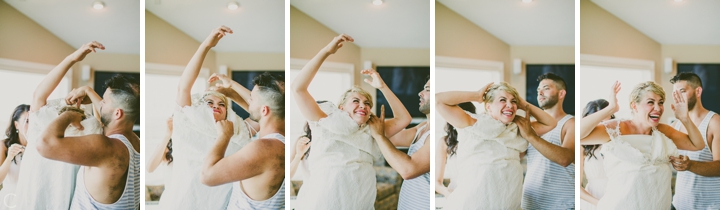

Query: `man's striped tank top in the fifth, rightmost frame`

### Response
(673, 111, 720, 210)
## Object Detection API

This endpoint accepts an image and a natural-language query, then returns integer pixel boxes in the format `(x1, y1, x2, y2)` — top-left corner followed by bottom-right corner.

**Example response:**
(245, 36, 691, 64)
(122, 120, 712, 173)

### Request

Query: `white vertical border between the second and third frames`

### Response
(283, 0, 294, 209)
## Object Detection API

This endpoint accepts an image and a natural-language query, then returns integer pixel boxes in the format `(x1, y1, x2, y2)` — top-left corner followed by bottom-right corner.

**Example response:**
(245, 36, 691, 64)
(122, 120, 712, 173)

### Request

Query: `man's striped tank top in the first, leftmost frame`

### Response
(70, 134, 140, 210)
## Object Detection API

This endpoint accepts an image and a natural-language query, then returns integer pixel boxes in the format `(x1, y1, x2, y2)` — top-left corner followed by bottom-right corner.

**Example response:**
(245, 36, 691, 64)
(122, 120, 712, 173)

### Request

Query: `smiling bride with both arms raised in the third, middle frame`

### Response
(292, 34, 411, 209)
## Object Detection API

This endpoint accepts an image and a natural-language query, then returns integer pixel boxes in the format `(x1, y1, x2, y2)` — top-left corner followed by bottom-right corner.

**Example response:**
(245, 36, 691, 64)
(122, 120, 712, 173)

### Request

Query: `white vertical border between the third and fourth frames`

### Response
(426, 0, 439, 209)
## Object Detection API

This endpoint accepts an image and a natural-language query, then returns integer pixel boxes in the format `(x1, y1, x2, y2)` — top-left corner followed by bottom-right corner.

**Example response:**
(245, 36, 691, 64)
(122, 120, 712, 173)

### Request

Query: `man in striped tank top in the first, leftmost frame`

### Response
(37, 72, 140, 209)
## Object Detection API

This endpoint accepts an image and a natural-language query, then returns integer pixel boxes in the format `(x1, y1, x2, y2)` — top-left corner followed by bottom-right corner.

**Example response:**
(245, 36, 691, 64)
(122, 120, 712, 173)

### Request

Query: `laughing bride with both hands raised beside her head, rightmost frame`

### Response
(580, 82, 705, 209)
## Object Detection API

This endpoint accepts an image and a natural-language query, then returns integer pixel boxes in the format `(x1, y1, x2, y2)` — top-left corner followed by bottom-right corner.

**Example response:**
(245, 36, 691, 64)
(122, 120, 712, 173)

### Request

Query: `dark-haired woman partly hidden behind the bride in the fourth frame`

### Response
(435, 102, 475, 197)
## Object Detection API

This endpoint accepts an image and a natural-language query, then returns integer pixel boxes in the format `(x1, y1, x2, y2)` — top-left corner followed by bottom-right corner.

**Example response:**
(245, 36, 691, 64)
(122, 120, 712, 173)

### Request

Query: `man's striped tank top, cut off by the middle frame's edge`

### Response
(398, 124, 430, 210)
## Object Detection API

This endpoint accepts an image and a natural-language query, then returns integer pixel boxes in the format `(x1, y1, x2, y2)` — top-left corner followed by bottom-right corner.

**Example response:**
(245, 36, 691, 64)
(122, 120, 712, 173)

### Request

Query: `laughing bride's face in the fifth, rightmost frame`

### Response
(632, 91, 665, 127)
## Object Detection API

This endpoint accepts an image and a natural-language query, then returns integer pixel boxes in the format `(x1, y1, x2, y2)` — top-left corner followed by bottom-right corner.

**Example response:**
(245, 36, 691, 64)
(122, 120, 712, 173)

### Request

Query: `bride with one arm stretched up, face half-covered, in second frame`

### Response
(159, 26, 255, 209)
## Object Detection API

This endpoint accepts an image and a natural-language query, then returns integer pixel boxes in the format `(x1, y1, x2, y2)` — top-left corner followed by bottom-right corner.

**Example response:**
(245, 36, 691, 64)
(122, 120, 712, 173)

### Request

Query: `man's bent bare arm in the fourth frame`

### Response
(515, 116, 575, 167)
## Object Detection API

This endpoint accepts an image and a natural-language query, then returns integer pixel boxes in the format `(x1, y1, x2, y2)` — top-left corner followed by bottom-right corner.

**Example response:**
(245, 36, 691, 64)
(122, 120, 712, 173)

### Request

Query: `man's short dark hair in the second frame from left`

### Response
(253, 72, 285, 119)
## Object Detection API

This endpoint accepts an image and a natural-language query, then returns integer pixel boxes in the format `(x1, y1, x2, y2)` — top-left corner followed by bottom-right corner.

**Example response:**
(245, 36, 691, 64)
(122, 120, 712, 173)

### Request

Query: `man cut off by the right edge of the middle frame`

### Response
(369, 78, 432, 210)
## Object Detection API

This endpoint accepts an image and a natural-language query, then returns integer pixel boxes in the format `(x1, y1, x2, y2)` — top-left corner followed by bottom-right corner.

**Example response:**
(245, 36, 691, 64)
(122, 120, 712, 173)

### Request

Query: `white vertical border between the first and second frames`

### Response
(138, 0, 148, 209)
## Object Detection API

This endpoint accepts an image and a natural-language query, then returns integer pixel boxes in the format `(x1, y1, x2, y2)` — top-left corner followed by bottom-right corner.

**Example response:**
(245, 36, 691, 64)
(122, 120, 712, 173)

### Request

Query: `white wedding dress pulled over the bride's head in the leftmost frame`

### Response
(8, 99, 103, 209)
